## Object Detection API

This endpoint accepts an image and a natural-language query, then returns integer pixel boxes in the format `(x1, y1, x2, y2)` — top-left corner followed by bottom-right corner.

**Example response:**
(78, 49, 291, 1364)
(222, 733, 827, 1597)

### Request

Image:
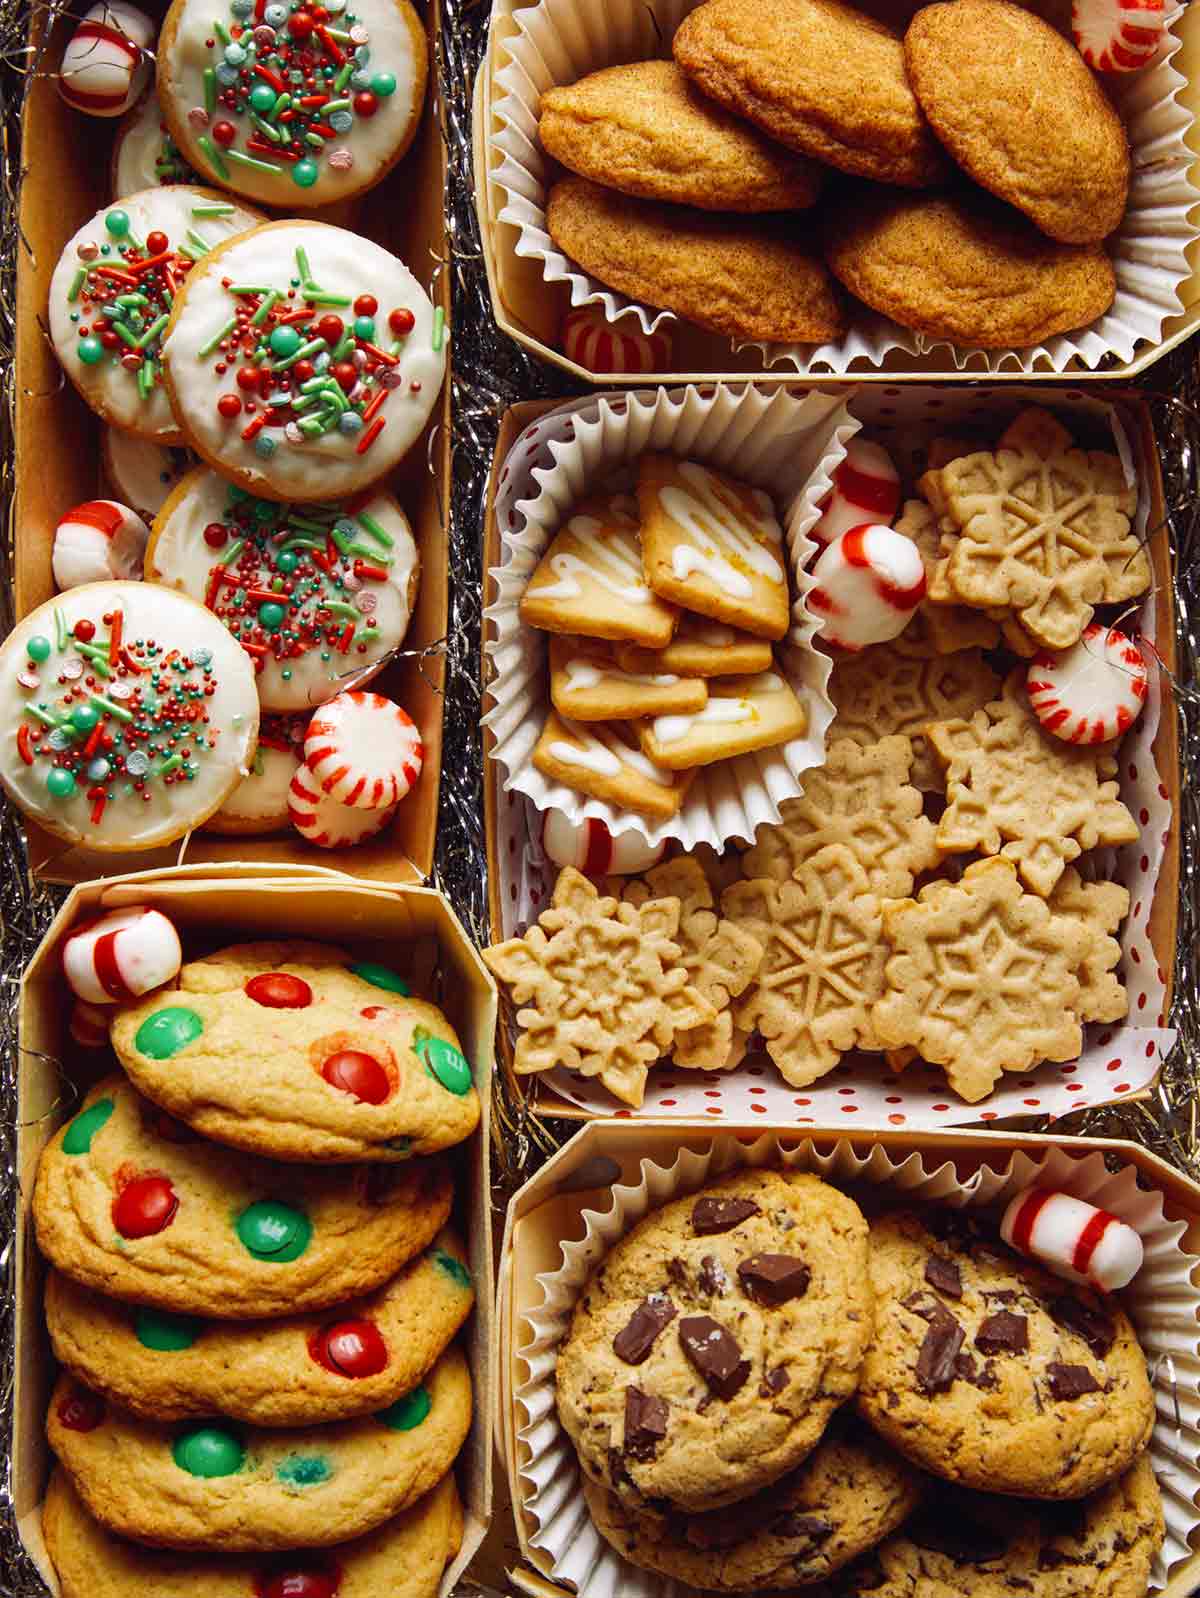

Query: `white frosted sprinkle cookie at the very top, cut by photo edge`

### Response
(158, 0, 428, 211)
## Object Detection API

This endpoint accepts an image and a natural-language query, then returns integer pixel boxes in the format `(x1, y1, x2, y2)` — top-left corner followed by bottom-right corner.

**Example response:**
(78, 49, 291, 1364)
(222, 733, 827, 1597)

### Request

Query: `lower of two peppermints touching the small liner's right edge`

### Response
(809, 526, 925, 652)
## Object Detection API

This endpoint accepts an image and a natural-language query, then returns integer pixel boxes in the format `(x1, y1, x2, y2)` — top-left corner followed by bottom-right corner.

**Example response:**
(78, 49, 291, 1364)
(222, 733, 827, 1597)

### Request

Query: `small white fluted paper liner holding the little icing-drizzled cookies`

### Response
(483, 385, 858, 849)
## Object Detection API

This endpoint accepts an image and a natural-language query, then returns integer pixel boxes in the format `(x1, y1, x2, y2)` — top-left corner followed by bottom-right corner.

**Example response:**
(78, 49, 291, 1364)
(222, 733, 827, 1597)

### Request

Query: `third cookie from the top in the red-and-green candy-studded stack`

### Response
(46, 1232, 475, 1425)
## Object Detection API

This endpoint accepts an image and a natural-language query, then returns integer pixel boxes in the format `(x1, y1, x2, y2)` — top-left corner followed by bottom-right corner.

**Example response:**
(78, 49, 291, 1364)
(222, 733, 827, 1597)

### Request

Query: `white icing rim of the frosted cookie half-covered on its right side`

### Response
(50, 184, 262, 443)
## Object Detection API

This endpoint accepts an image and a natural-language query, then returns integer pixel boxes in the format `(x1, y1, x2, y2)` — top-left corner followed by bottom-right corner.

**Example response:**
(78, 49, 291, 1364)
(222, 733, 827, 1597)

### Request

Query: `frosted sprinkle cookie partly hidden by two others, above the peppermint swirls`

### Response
(145, 467, 420, 711)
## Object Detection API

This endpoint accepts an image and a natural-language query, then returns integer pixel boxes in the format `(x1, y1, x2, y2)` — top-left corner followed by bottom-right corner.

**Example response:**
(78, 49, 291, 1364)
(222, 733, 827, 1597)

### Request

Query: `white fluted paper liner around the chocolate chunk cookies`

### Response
(515, 1135, 1200, 1598)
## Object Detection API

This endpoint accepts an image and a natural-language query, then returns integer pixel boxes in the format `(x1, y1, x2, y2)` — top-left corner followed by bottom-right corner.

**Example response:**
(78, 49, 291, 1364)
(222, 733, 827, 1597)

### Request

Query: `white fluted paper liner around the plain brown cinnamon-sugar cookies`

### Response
(489, 0, 1200, 376)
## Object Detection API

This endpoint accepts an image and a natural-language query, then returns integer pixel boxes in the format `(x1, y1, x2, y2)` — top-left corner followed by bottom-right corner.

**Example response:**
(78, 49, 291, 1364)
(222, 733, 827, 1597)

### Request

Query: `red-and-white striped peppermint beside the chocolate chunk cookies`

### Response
(1000, 1187, 1142, 1293)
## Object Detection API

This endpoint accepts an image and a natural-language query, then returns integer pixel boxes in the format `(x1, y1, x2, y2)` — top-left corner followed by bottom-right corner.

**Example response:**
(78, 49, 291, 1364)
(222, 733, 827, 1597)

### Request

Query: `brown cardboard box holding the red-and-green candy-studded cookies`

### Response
(11, 866, 495, 1598)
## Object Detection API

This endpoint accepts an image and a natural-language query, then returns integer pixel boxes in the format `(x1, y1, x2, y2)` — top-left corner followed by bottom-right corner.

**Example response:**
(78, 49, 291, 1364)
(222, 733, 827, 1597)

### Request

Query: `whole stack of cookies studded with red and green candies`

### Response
(34, 943, 479, 1598)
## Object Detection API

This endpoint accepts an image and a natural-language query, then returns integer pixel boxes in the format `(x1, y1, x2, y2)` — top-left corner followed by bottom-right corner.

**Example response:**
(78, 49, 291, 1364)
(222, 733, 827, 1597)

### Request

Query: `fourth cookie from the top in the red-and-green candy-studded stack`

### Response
(46, 1347, 471, 1553)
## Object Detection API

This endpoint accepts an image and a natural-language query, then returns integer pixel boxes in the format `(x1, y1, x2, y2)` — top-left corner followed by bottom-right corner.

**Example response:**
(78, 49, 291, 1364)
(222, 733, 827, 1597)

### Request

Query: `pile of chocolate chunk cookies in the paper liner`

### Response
(556, 1170, 1165, 1598)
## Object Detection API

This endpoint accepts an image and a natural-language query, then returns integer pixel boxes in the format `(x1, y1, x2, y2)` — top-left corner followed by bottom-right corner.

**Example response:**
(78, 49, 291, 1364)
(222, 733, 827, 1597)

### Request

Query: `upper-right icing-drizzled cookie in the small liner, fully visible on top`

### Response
(638, 455, 788, 638)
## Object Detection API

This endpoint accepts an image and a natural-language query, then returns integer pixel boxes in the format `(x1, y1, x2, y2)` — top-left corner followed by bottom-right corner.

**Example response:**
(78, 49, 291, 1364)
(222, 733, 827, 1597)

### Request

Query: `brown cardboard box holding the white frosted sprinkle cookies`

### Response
(13, 0, 451, 882)
